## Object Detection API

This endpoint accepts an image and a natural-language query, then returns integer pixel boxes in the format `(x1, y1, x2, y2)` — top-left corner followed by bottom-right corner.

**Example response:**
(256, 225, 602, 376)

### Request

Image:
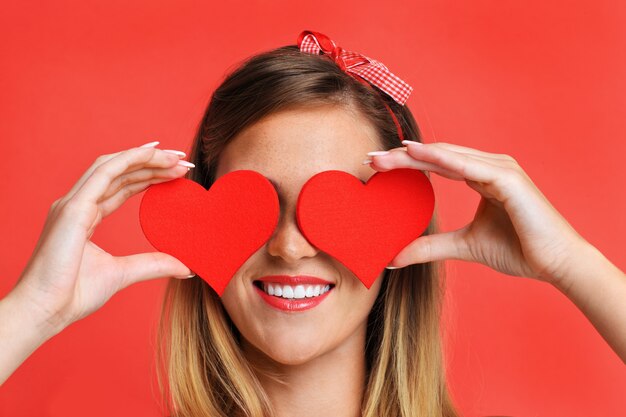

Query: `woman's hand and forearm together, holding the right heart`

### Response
(371, 141, 626, 363)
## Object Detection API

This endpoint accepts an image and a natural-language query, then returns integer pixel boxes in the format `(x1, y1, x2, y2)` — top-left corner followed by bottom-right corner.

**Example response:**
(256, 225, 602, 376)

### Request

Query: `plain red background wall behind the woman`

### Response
(0, 0, 626, 417)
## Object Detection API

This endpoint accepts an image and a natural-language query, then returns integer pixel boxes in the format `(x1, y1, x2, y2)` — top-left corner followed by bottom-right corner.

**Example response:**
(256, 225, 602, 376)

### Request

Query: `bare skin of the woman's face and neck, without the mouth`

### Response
(216, 106, 382, 416)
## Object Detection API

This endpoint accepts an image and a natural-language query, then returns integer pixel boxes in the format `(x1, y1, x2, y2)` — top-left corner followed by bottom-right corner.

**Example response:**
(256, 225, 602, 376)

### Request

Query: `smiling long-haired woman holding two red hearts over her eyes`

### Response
(0, 30, 626, 416)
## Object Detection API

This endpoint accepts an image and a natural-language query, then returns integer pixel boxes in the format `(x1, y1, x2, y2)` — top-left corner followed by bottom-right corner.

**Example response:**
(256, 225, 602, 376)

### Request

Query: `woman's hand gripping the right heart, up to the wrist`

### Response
(370, 141, 588, 284)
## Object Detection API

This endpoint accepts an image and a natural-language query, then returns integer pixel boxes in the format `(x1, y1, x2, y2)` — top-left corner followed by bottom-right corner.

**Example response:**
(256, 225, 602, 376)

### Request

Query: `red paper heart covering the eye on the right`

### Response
(296, 168, 435, 288)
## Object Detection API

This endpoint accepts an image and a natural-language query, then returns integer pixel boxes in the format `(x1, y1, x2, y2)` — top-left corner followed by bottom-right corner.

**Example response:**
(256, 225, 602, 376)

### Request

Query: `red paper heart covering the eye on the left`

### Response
(139, 170, 280, 296)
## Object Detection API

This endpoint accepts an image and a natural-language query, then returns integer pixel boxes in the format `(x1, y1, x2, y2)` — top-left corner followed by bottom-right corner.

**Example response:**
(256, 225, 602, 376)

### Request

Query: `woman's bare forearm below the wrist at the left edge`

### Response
(0, 291, 61, 385)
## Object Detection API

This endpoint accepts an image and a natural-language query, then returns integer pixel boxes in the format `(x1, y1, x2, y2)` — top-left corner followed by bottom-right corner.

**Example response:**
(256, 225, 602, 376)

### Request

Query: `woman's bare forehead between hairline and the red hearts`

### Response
(216, 105, 381, 188)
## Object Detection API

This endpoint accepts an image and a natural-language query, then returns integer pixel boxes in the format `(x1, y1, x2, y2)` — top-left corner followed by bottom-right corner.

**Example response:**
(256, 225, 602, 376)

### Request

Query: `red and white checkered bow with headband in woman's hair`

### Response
(298, 30, 413, 141)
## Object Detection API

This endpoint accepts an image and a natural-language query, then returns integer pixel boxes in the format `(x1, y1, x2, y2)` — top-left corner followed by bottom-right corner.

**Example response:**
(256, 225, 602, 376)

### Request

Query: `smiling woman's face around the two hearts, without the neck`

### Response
(216, 105, 382, 365)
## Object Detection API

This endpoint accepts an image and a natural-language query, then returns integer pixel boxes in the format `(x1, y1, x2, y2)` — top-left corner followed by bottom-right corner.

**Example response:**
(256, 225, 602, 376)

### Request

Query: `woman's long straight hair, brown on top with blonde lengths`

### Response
(156, 45, 458, 417)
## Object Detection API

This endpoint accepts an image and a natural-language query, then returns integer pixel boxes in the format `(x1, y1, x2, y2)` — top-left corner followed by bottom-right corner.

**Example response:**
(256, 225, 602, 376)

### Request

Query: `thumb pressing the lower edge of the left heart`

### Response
(116, 252, 196, 288)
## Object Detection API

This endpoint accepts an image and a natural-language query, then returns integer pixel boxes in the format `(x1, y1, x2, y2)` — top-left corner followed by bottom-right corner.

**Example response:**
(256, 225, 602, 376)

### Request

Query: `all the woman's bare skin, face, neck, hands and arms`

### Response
(0, 101, 626, 416)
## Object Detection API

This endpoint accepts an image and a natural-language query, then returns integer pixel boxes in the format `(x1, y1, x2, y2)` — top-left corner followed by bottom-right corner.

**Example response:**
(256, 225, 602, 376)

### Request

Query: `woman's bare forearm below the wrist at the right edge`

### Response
(554, 244, 626, 363)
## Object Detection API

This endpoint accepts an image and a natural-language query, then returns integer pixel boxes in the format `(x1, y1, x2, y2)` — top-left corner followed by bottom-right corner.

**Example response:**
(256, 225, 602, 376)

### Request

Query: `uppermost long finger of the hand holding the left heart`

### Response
(75, 148, 186, 202)
